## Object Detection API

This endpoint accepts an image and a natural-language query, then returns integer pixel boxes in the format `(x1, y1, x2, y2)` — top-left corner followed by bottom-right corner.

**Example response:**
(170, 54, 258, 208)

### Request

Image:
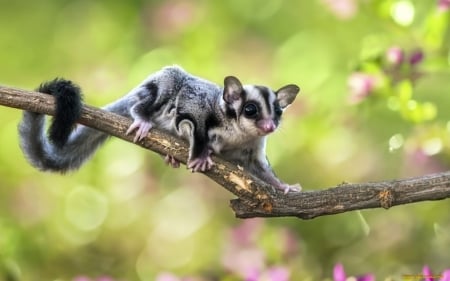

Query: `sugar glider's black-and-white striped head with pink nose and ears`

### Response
(223, 76, 300, 136)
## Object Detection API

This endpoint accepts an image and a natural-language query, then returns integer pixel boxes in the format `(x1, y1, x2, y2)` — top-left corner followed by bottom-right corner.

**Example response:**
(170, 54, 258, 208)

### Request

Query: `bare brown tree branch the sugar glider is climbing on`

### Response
(0, 86, 450, 219)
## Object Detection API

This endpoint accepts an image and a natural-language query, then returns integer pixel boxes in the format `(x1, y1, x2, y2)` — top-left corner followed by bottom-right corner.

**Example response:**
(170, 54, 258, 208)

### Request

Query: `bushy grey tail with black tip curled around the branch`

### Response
(19, 78, 116, 173)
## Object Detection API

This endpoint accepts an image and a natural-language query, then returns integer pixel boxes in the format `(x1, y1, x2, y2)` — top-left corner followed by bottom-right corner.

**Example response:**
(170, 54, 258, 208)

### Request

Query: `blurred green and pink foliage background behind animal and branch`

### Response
(0, 0, 450, 281)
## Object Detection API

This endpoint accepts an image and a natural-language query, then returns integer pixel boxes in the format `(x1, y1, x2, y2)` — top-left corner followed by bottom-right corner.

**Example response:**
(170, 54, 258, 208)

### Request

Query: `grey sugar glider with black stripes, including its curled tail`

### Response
(19, 66, 301, 193)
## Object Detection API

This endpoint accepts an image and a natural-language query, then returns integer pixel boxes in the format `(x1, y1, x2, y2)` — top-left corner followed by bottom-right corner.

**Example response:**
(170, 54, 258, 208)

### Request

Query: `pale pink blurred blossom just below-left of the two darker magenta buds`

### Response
(347, 72, 376, 104)
